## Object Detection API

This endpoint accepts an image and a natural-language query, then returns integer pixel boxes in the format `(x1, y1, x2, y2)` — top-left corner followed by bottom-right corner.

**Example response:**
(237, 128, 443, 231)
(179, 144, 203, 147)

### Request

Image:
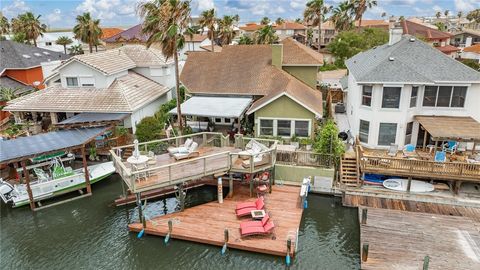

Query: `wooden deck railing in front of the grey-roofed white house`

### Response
(360, 155, 480, 182)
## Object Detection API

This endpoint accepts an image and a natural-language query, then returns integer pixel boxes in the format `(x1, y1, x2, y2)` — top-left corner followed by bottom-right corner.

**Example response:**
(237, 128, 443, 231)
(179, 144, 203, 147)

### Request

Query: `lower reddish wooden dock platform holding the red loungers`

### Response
(128, 184, 303, 256)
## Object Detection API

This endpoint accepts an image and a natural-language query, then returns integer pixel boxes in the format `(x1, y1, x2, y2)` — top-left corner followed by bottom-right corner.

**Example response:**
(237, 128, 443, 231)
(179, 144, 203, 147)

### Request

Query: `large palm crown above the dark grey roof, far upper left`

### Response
(12, 12, 47, 47)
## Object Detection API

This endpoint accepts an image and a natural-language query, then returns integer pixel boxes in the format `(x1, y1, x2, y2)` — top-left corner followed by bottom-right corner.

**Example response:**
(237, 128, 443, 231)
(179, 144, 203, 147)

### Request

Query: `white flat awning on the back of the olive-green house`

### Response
(170, 96, 252, 118)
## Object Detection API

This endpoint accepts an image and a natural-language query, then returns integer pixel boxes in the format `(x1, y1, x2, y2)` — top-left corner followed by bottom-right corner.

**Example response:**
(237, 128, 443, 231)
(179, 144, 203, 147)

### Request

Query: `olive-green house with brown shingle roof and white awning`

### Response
(178, 38, 323, 138)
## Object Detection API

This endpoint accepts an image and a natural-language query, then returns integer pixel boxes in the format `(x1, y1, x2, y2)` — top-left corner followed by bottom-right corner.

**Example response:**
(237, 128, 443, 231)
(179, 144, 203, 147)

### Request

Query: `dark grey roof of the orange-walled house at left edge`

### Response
(0, 40, 70, 73)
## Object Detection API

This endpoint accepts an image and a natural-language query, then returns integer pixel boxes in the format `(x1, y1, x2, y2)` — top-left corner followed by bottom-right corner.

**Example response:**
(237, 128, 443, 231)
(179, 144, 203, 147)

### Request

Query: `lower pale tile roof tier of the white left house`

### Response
(4, 71, 169, 113)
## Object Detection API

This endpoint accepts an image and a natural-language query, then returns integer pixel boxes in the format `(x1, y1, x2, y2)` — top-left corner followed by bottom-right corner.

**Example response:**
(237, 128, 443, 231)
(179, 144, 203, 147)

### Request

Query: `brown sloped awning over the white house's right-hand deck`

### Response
(415, 115, 480, 141)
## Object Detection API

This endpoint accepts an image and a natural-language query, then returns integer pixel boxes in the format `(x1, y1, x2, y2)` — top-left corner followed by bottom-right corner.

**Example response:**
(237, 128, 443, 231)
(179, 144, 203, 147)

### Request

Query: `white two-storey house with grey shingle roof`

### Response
(344, 31, 480, 148)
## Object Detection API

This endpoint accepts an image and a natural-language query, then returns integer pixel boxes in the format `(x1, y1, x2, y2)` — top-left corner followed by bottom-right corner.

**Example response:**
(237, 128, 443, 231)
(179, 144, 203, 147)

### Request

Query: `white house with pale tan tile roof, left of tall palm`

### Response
(4, 45, 175, 132)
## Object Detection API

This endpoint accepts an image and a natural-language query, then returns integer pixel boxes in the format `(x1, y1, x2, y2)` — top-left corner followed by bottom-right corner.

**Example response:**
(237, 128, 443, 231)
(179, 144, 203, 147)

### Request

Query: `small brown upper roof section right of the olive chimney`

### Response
(282, 38, 323, 66)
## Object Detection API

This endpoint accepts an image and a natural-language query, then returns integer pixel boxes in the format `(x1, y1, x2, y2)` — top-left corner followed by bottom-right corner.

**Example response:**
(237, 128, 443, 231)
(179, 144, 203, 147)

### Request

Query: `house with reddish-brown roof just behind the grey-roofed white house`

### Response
(400, 20, 459, 58)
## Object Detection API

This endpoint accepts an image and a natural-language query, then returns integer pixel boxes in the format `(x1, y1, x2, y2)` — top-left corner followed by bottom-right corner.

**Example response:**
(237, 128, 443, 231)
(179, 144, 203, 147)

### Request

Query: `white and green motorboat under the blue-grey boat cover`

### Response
(0, 156, 115, 208)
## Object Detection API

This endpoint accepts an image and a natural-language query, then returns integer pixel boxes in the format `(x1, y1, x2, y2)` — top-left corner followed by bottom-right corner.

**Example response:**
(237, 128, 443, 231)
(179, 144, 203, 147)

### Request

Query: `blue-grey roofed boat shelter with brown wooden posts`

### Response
(0, 127, 109, 210)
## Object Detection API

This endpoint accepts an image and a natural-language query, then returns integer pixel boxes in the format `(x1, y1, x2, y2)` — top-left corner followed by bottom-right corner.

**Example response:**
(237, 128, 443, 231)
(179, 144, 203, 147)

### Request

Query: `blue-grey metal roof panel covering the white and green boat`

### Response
(0, 127, 108, 163)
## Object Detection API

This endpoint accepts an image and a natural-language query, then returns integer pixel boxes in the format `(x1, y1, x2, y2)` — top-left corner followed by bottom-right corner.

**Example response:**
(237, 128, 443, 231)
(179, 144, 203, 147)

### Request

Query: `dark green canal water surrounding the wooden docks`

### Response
(0, 175, 359, 270)
